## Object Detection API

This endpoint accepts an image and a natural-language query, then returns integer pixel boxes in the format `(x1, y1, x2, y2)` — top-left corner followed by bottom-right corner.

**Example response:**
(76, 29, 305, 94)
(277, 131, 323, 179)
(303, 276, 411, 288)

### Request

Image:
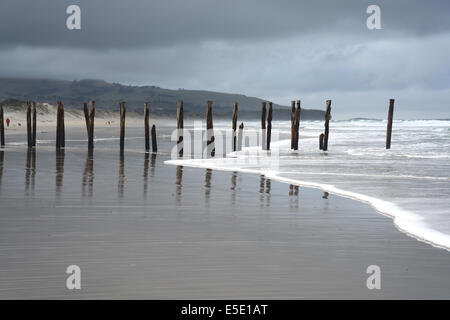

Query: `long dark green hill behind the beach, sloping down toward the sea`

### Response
(0, 78, 324, 120)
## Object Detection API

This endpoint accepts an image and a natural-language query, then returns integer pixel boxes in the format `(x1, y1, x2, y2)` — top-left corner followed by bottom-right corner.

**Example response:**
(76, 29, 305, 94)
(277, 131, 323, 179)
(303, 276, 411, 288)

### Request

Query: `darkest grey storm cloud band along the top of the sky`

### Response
(0, 0, 450, 49)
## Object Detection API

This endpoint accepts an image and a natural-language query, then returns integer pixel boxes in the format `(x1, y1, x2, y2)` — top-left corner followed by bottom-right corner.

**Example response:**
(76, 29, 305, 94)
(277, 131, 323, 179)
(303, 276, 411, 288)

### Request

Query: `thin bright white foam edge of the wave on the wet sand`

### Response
(164, 159, 450, 251)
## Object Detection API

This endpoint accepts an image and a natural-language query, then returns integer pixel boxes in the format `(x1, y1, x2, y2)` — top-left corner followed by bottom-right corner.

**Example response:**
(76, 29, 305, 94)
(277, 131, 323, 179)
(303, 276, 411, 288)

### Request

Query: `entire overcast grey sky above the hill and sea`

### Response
(0, 0, 450, 118)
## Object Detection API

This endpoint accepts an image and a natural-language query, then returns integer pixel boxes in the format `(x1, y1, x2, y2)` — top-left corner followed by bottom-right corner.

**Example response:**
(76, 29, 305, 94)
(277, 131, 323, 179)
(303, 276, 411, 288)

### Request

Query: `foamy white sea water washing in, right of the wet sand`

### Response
(167, 120, 450, 250)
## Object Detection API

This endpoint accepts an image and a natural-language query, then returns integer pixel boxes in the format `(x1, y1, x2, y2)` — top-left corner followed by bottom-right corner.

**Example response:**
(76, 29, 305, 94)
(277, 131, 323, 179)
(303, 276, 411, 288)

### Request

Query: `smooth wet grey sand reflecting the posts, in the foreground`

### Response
(0, 128, 450, 299)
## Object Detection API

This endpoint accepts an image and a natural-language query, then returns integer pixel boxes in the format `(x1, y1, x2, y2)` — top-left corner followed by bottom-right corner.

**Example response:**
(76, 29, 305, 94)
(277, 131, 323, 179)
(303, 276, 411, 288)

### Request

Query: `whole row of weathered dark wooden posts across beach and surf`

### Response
(0, 99, 394, 151)
